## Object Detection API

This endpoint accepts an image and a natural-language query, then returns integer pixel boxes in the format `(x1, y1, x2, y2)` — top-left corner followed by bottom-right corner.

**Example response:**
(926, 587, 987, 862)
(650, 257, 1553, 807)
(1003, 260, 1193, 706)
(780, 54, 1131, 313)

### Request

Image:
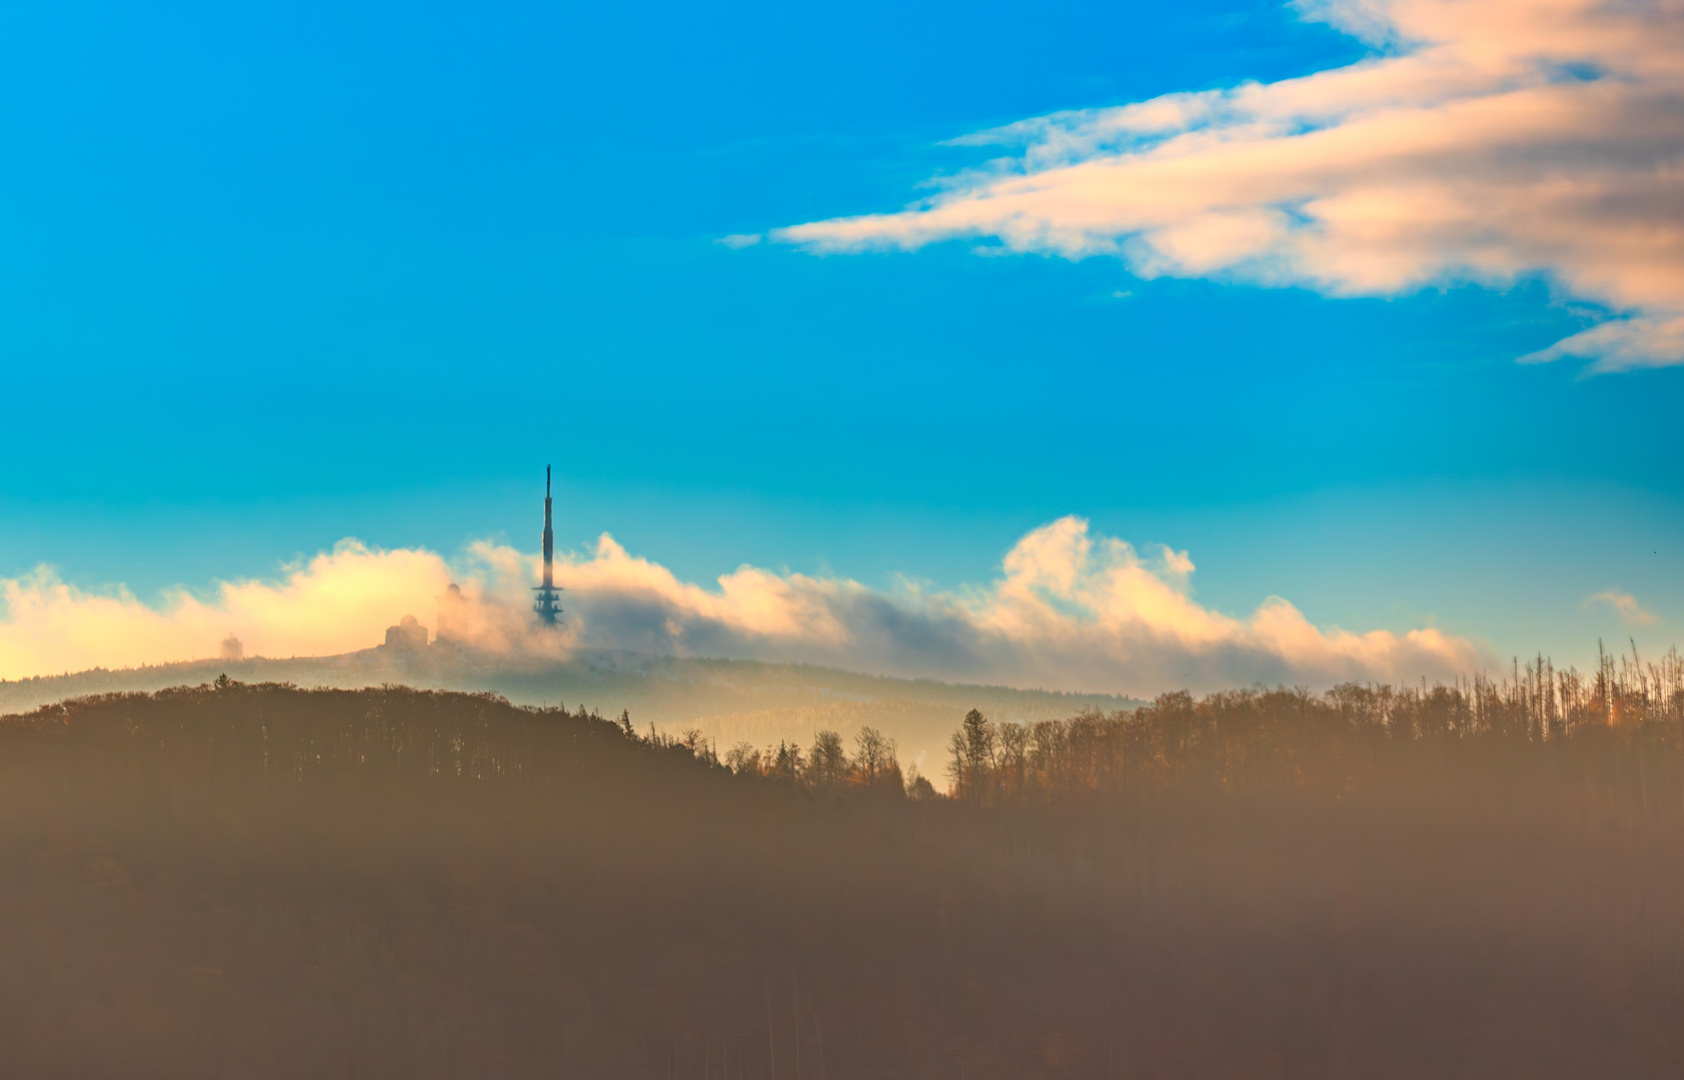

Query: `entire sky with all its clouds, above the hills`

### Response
(0, 0, 1684, 692)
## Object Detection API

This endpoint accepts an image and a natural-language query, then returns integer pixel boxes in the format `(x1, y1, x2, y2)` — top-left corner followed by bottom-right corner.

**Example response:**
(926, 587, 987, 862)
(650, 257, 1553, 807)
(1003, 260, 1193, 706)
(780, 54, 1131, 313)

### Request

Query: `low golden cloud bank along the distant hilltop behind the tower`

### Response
(0, 517, 1485, 694)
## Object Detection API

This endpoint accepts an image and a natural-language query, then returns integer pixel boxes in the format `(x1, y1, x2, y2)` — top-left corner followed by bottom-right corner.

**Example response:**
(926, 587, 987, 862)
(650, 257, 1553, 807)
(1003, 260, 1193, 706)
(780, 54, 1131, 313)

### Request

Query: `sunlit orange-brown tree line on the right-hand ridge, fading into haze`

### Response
(946, 647, 1684, 809)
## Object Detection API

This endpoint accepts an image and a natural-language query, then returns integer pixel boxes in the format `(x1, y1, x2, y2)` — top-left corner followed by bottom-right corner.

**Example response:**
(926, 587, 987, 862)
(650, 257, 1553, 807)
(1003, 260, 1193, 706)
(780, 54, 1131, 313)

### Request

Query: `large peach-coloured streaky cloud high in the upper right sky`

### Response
(773, 0, 1684, 371)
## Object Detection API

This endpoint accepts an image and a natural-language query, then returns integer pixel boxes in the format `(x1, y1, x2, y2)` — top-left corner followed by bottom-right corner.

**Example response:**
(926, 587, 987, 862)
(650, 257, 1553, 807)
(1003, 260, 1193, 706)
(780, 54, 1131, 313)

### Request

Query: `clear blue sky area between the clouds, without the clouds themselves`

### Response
(0, 2, 1684, 680)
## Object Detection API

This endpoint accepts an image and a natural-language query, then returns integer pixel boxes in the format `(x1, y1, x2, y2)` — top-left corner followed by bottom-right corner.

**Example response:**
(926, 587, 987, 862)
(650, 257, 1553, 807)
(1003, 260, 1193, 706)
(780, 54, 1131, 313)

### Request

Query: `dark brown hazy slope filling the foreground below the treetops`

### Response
(0, 684, 1684, 1080)
